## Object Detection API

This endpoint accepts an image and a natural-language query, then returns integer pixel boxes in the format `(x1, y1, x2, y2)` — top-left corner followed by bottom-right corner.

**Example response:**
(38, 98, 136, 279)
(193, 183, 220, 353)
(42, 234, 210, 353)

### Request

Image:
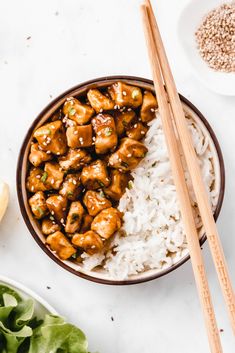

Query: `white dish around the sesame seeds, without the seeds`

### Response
(177, 0, 235, 96)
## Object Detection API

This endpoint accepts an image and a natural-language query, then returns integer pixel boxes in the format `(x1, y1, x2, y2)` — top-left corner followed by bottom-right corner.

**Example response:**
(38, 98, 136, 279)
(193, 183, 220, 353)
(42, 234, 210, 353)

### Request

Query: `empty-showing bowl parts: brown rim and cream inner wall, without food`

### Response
(17, 76, 225, 285)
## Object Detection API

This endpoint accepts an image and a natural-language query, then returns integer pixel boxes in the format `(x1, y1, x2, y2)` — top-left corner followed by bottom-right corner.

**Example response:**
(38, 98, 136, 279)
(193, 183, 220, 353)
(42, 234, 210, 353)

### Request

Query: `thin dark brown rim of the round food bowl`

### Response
(16, 75, 225, 285)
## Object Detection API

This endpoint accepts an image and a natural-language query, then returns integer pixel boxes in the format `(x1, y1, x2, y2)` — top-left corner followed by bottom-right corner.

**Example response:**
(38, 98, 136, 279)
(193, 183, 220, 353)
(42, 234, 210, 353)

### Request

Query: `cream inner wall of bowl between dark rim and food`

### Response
(21, 79, 221, 283)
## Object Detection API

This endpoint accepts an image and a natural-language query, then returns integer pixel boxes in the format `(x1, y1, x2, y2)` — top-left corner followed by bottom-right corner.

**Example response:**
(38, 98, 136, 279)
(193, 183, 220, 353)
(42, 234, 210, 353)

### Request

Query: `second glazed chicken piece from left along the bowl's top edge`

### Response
(87, 88, 114, 113)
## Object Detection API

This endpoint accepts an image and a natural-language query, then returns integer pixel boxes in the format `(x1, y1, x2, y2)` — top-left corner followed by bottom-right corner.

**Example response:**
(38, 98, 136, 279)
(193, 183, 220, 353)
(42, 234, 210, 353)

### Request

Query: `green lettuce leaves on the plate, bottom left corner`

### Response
(0, 285, 88, 353)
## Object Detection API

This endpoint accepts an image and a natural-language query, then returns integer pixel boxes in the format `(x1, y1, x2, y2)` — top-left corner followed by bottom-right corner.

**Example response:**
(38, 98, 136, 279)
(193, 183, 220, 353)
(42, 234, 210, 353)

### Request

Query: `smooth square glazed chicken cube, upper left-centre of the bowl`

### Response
(66, 124, 93, 148)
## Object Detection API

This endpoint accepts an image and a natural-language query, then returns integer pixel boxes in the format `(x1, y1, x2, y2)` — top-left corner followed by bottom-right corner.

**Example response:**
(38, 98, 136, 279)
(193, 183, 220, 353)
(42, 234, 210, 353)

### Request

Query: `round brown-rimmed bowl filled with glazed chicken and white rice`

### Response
(17, 76, 225, 285)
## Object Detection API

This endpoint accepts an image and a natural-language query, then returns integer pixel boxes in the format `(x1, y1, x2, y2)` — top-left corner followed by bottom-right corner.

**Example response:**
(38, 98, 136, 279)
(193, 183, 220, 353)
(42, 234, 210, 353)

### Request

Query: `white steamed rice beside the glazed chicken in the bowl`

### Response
(82, 110, 218, 279)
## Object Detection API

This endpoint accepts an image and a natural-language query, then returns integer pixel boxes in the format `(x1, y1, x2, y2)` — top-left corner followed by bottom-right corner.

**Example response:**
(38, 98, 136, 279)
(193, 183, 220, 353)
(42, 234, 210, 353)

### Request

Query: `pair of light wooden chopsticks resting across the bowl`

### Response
(141, 0, 235, 353)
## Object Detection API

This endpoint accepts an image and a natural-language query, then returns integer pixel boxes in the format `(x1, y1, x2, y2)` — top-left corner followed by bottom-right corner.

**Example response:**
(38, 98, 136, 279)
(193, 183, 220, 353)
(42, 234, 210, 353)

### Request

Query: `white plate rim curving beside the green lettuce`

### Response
(0, 276, 58, 319)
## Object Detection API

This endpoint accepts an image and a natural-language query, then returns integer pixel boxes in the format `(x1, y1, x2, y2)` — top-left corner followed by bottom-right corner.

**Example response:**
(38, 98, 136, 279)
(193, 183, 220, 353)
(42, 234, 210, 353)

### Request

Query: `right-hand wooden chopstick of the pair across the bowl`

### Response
(145, 0, 235, 335)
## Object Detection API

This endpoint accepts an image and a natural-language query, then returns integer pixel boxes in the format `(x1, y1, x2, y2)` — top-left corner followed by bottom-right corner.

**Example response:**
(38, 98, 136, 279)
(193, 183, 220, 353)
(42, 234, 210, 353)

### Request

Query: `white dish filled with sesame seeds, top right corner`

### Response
(178, 0, 235, 96)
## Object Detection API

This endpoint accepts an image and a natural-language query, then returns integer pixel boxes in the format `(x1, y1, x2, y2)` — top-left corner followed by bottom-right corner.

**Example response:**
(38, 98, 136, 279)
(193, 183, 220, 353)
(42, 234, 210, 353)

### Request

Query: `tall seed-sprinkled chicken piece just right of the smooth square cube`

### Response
(92, 114, 118, 154)
